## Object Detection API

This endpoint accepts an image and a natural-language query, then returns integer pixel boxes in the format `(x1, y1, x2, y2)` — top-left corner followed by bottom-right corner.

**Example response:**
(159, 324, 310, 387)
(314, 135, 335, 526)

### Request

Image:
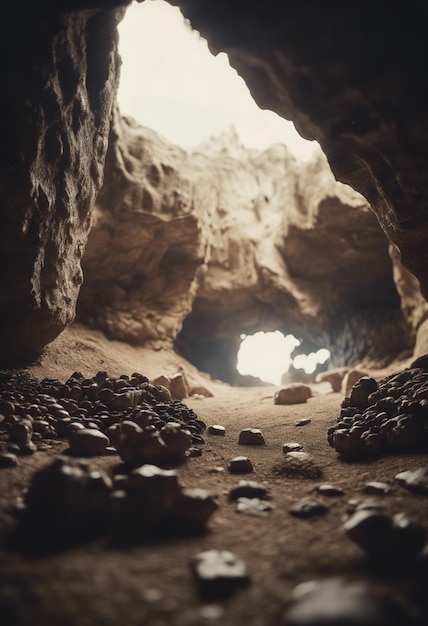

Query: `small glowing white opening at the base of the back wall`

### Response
(237, 330, 330, 385)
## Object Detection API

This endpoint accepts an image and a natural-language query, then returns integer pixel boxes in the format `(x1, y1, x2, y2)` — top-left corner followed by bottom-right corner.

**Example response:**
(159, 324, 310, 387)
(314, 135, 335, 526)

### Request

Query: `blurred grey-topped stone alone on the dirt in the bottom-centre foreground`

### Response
(192, 550, 250, 600)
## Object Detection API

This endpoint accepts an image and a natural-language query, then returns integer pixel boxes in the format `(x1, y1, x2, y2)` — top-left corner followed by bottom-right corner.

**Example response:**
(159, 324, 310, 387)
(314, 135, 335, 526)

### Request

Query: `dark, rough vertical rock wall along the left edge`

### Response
(0, 2, 122, 365)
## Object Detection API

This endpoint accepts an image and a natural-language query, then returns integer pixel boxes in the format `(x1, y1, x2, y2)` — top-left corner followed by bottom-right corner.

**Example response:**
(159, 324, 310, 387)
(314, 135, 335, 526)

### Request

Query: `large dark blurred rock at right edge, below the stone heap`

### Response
(344, 510, 426, 562)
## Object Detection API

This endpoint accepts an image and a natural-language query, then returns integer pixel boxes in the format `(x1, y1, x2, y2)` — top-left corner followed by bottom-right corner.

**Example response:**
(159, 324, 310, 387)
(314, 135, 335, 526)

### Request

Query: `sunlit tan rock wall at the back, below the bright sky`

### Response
(78, 110, 414, 382)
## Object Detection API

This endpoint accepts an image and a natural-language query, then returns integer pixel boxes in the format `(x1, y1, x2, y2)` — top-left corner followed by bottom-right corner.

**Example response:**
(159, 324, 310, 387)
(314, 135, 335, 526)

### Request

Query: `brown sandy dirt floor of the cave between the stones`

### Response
(0, 326, 428, 626)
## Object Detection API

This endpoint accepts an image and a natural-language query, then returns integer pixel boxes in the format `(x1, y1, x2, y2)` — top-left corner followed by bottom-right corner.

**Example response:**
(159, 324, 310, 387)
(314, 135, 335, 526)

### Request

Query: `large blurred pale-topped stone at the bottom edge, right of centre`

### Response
(280, 577, 411, 626)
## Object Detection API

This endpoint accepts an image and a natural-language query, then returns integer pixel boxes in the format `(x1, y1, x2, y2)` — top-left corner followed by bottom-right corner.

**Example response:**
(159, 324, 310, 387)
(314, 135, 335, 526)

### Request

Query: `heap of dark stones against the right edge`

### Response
(328, 362, 428, 459)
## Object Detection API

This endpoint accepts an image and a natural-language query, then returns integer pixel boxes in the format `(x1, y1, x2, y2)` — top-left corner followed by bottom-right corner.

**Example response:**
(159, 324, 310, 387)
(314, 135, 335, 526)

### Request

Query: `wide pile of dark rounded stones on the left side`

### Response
(0, 371, 206, 465)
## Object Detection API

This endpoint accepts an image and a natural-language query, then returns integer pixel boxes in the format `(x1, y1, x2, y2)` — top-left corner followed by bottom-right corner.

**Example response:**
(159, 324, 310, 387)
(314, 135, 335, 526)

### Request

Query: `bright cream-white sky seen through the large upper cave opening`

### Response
(118, 0, 318, 160)
